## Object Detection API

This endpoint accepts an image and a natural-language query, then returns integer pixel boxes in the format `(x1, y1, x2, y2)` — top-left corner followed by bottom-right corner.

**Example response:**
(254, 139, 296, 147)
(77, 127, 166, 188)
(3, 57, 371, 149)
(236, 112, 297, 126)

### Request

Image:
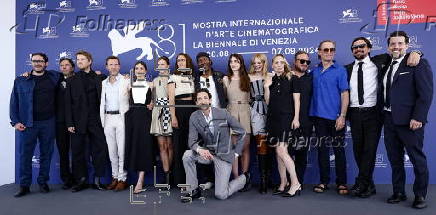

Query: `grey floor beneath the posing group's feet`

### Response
(0, 184, 436, 215)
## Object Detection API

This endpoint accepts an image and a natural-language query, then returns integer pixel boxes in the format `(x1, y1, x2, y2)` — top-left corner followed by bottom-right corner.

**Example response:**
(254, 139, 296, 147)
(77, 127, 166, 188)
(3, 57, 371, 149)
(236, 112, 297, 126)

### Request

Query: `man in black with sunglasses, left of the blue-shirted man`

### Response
(290, 51, 313, 184)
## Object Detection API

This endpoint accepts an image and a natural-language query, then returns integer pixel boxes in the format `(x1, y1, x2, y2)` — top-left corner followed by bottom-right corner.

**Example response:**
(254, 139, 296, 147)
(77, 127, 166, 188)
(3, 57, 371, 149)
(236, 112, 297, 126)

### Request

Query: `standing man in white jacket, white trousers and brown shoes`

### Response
(100, 56, 129, 191)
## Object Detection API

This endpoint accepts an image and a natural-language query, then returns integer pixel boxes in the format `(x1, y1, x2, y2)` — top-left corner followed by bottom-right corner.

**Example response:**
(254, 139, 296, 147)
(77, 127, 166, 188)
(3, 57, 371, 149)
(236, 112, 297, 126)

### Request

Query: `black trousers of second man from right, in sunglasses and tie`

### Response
(349, 107, 382, 186)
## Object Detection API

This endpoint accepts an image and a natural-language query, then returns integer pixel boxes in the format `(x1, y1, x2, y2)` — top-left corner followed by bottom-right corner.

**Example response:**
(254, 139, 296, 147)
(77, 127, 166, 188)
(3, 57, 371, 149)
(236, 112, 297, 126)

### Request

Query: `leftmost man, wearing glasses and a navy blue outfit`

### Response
(10, 53, 59, 197)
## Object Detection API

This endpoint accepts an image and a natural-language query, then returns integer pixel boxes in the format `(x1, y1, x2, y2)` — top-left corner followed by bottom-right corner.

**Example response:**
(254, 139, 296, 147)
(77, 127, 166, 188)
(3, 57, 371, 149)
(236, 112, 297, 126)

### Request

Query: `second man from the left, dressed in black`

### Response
(56, 58, 75, 190)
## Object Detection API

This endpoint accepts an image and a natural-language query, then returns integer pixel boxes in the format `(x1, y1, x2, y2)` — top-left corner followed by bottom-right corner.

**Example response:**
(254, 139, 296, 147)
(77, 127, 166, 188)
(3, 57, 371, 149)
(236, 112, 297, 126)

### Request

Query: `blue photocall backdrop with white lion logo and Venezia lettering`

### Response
(11, 0, 436, 184)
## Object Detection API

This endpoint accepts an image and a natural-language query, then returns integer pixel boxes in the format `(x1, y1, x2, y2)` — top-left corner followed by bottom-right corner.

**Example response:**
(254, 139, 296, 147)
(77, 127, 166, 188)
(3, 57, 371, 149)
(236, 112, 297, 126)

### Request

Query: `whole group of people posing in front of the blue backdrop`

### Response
(10, 31, 433, 208)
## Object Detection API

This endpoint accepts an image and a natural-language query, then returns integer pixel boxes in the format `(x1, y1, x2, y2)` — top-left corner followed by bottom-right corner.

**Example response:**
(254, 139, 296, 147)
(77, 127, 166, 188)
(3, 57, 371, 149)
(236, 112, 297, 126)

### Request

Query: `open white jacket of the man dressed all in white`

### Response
(100, 74, 130, 127)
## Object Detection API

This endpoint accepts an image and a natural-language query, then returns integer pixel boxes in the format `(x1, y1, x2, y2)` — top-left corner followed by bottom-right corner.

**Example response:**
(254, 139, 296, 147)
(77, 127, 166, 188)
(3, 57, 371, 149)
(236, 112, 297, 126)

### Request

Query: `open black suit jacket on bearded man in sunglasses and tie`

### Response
(345, 54, 390, 123)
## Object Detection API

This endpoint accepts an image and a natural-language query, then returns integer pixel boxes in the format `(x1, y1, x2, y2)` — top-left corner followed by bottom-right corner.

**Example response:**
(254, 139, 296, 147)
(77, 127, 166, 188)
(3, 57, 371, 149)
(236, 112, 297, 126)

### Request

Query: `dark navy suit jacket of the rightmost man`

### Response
(382, 54, 433, 125)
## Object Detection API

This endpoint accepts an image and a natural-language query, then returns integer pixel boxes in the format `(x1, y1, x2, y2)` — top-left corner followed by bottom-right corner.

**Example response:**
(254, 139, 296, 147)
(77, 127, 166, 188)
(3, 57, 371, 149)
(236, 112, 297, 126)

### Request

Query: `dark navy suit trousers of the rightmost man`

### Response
(384, 111, 429, 197)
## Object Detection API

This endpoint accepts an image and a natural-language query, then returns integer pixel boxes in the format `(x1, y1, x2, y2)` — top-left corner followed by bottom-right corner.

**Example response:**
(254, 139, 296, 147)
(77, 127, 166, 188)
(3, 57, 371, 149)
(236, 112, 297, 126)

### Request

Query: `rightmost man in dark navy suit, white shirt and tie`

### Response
(383, 31, 433, 209)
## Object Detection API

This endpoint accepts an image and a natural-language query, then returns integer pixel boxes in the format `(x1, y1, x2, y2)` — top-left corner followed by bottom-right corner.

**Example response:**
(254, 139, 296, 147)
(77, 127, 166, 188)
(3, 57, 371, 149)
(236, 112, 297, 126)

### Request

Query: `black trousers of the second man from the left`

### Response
(56, 122, 73, 183)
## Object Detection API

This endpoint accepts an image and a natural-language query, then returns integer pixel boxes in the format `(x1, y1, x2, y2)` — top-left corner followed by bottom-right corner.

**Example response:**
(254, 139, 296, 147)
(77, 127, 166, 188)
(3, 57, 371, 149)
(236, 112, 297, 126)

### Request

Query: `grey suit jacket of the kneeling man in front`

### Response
(188, 107, 245, 163)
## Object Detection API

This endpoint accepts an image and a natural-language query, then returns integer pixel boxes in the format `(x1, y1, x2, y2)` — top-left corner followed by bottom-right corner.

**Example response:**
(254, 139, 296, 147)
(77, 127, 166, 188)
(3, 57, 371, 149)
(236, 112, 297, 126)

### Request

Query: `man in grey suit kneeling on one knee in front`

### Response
(182, 89, 250, 202)
